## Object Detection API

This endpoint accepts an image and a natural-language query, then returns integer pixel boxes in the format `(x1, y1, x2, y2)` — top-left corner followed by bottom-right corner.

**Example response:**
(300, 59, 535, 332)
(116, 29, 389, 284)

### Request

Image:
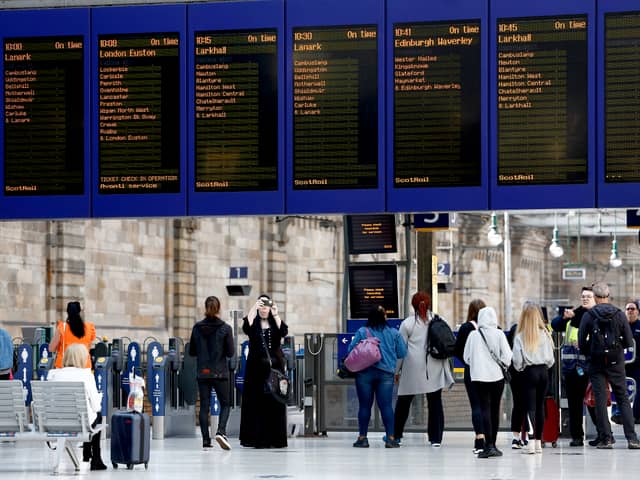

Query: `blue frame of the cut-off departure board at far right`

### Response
(597, 0, 640, 208)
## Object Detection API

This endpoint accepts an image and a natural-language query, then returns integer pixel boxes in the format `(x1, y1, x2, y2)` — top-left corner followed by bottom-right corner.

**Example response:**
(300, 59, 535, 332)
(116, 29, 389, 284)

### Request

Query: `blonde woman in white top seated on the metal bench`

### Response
(47, 343, 107, 470)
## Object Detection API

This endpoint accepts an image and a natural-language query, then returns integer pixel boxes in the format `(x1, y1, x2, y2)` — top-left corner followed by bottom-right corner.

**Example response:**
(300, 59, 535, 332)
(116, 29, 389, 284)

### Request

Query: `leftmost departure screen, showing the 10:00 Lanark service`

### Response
(3, 36, 85, 196)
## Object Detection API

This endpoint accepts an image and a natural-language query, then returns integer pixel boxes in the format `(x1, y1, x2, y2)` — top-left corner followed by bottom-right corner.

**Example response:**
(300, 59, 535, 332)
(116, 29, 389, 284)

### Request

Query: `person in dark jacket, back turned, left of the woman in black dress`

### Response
(189, 297, 234, 450)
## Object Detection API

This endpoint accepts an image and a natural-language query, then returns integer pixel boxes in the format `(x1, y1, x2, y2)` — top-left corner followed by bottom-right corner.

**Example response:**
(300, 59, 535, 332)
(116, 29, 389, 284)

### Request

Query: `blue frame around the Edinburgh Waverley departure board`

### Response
(385, 0, 490, 212)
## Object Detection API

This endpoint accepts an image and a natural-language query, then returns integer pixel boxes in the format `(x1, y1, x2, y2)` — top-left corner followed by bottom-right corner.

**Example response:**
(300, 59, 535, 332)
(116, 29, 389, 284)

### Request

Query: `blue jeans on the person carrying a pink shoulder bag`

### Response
(356, 367, 393, 437)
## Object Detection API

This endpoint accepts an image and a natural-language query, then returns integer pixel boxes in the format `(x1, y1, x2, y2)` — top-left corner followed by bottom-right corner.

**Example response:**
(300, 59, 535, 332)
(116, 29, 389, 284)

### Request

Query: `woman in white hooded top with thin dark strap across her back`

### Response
(463, 307, 511, 458)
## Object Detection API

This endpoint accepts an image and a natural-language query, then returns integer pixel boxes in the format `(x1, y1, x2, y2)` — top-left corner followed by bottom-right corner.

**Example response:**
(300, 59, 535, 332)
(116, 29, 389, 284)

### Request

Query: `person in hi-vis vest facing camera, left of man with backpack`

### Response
(551, 287, 597, 447)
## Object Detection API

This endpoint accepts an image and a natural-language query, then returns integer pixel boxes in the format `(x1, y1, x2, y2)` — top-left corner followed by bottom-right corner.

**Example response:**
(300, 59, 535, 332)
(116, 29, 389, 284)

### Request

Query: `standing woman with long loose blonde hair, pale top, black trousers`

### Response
(513, 302, 554, 453)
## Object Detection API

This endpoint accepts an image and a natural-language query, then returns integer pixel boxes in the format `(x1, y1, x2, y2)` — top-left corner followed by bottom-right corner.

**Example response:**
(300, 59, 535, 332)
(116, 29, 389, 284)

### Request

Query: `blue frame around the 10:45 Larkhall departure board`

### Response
(489, 0, 596, 210)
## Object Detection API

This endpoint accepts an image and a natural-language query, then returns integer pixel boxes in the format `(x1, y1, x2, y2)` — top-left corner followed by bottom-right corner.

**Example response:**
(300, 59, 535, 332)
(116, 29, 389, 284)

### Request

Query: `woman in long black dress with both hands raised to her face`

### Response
(240, 295, 289, 448)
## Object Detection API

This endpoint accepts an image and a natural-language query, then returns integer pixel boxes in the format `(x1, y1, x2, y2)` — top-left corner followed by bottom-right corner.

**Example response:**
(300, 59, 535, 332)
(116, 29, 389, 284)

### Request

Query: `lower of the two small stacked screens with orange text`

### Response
(349, 265, 398, 318)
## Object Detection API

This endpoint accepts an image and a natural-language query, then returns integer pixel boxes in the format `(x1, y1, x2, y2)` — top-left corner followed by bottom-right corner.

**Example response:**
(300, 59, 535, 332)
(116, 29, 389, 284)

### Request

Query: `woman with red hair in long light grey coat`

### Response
(394, 292, 454, 447)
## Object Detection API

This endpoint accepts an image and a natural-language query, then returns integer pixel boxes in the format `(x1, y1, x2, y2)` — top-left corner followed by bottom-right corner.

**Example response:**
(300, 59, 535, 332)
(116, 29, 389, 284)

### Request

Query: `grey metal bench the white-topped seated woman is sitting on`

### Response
(31, 380, 105, 473)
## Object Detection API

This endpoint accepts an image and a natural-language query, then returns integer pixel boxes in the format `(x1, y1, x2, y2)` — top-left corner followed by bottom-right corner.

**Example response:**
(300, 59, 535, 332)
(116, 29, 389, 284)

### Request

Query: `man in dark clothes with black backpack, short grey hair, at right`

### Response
(578, 282, 640, 450)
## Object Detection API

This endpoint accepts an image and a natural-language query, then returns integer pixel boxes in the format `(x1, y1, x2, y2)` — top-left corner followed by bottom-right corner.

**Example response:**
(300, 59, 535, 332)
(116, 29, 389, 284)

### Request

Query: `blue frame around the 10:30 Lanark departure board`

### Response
(285, 0, 385, 214)
